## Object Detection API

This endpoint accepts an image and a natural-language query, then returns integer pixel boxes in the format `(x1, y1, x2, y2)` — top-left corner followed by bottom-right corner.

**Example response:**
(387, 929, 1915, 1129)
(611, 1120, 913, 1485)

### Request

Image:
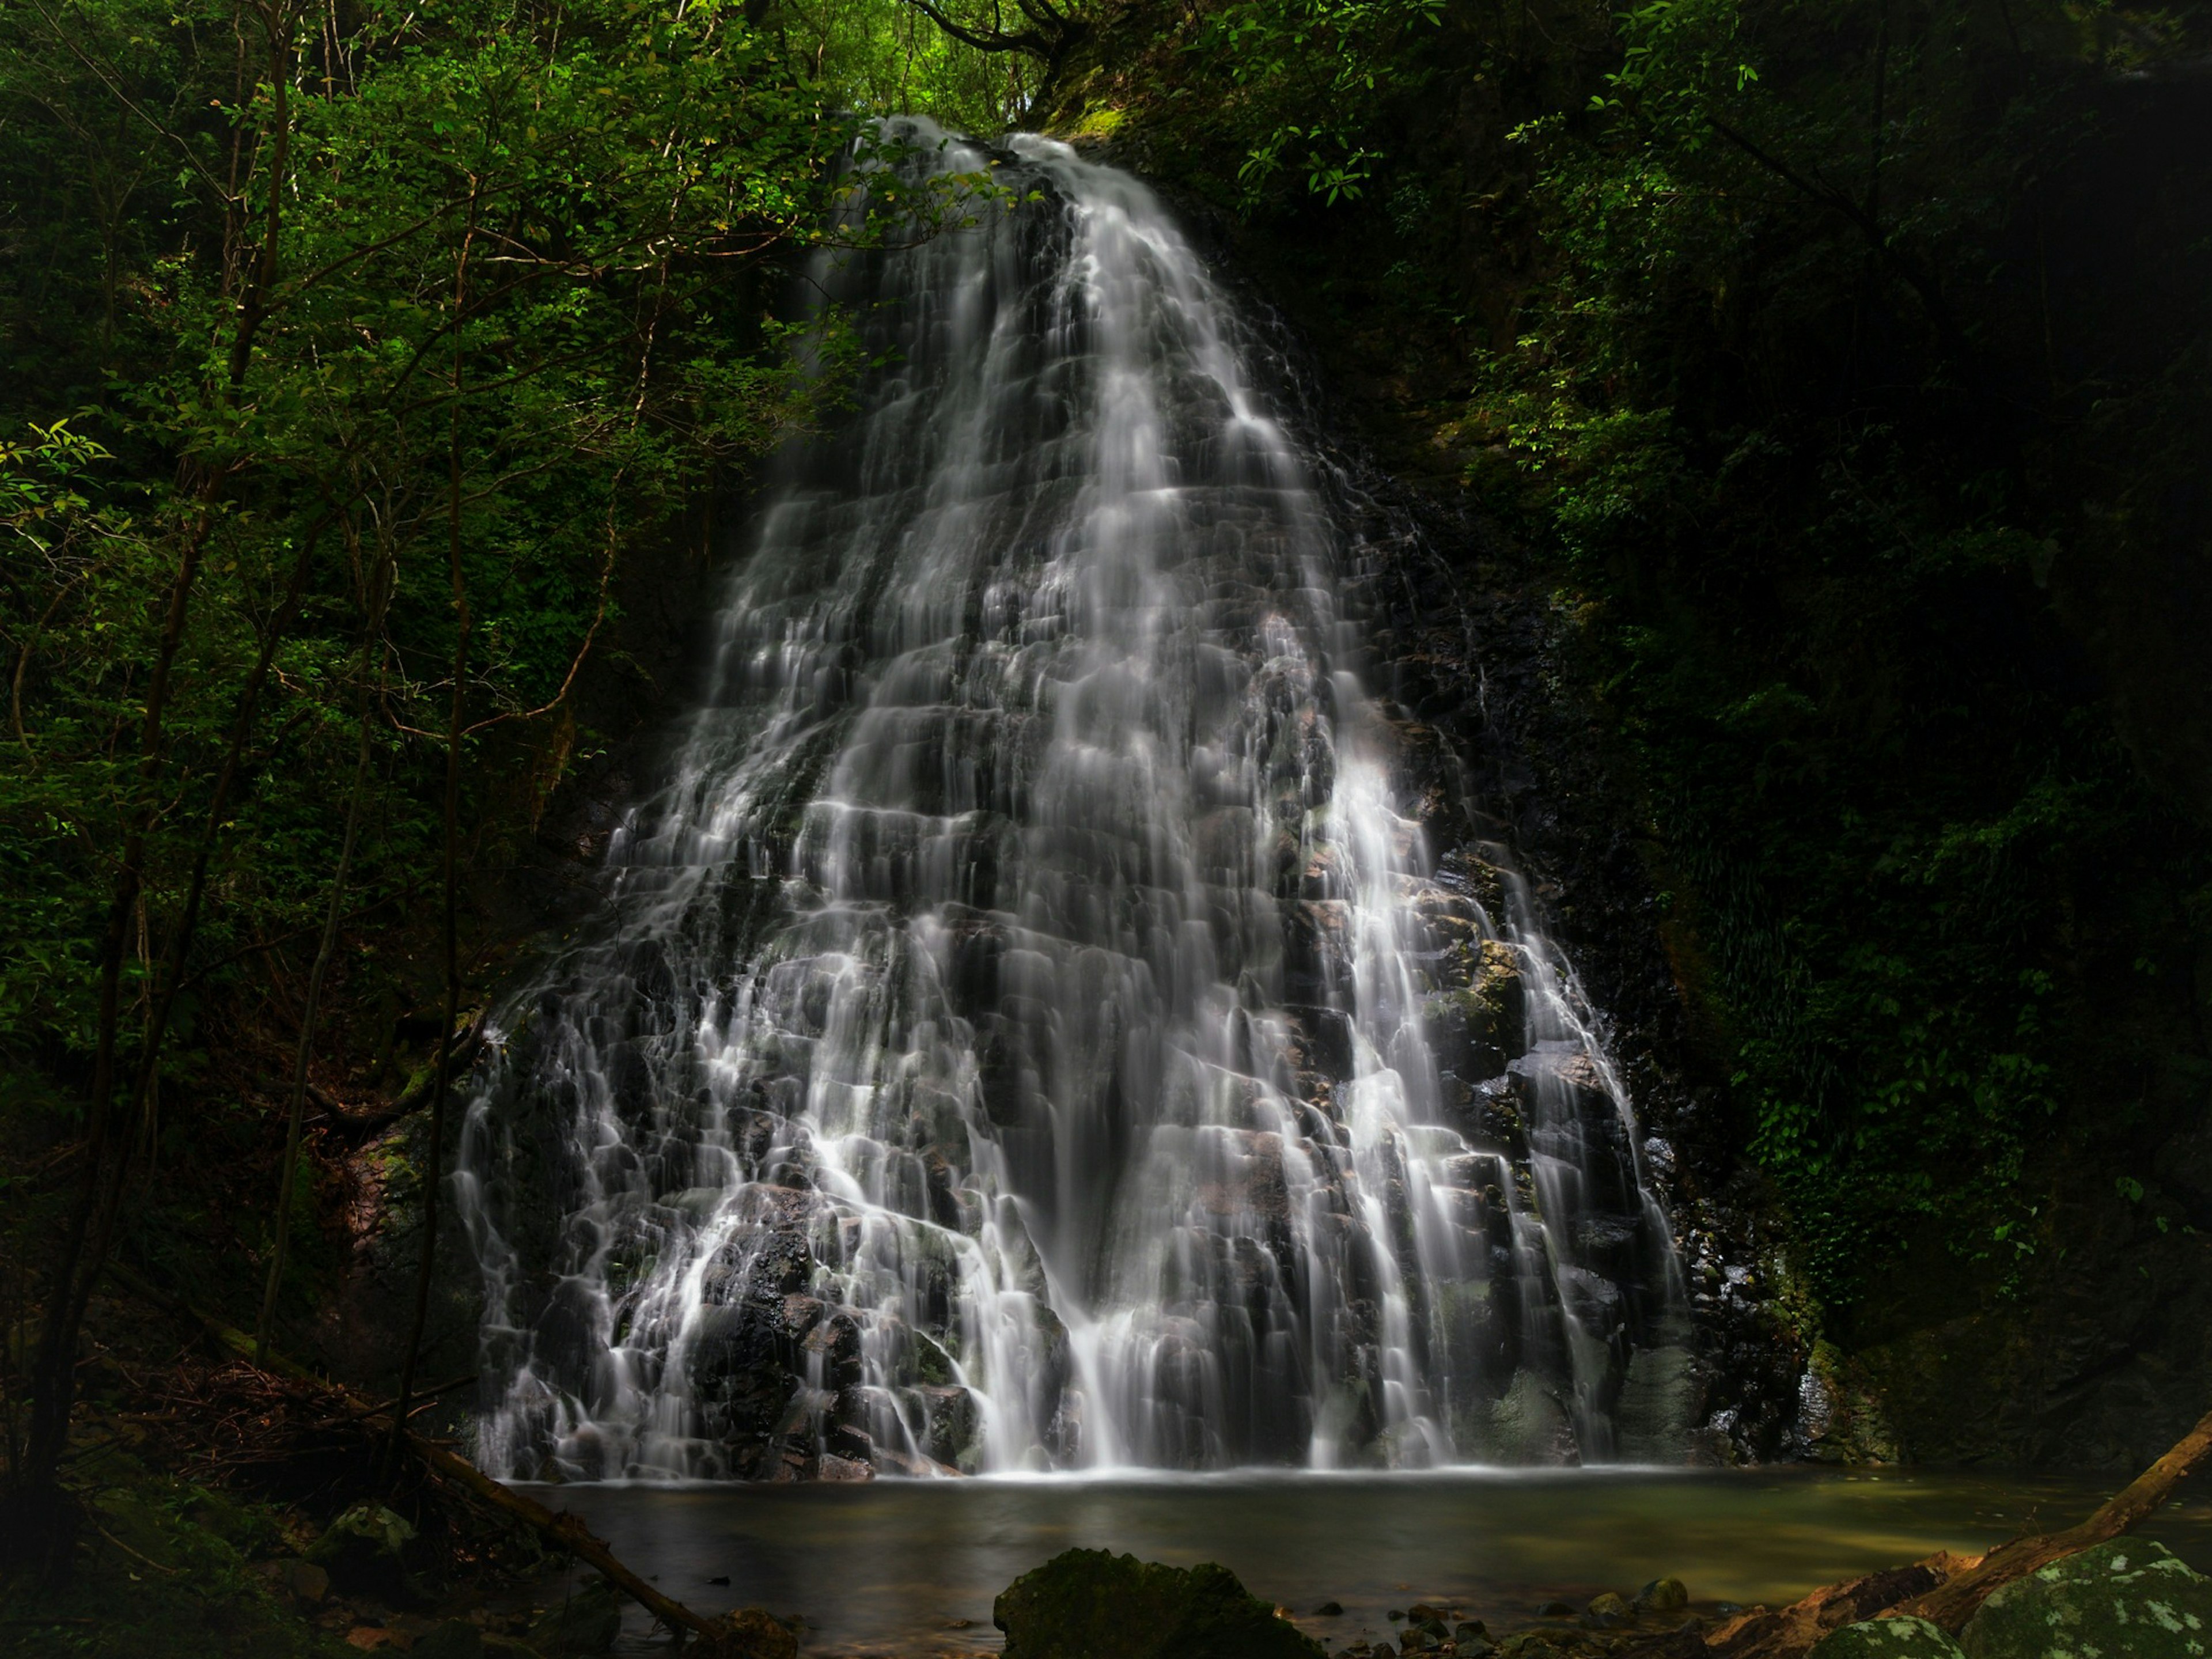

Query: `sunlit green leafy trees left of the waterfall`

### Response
(0, 0, 1070, 1396)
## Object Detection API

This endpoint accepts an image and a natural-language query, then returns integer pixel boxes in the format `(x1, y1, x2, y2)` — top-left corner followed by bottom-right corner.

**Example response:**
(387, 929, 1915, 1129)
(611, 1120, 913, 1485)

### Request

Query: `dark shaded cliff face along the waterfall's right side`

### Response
(1035, 7, 2212, 1469)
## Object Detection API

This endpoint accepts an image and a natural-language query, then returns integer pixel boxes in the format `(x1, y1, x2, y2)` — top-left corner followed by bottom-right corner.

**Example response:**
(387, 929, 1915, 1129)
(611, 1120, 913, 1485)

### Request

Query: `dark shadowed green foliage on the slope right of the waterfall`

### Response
(1458, 0, 2207, 1301)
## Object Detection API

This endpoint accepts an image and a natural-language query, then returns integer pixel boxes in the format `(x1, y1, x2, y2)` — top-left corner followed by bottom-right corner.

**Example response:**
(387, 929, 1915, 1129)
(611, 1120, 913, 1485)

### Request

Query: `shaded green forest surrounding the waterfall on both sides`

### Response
(0, 0, 2212, 1521)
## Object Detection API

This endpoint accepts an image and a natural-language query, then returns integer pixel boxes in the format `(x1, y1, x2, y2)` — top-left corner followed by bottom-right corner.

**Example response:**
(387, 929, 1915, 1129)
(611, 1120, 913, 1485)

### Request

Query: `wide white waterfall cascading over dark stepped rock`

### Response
(458, 126, 1683, 1478)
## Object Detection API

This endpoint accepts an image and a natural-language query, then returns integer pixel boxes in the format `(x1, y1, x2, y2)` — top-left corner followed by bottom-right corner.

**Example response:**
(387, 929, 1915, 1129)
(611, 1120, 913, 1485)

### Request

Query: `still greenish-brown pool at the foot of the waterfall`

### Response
(531, 1469, 2212, 1659)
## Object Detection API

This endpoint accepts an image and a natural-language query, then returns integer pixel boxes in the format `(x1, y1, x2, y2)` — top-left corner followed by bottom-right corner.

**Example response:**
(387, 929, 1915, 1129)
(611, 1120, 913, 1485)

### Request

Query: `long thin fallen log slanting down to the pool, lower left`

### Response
(106, 1261, 798, 1659)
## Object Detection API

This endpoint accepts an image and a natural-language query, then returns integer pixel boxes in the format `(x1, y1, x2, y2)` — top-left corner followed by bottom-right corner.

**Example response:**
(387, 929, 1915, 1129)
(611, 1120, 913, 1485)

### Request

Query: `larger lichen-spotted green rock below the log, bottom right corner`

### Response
(1960, 1537, 2212, 1659)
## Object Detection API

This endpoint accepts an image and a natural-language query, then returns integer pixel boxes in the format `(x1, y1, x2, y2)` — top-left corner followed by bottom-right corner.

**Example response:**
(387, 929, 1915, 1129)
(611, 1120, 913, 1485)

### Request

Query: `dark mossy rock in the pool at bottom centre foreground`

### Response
(991, 1551, 1323, 1659)
